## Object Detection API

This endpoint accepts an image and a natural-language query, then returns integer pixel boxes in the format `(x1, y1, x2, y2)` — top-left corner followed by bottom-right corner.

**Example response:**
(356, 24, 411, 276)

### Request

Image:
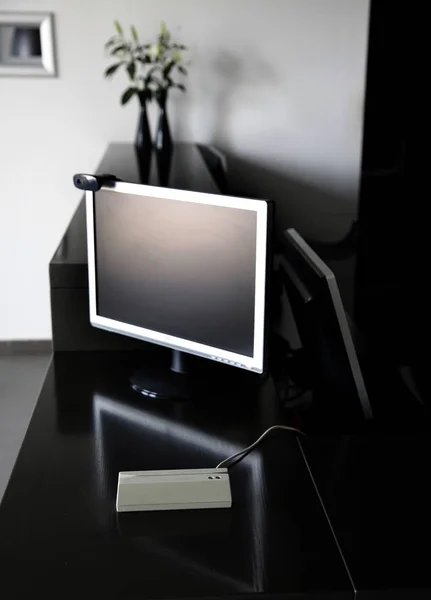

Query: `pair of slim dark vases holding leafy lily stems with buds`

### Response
(105, 21, 187, 156)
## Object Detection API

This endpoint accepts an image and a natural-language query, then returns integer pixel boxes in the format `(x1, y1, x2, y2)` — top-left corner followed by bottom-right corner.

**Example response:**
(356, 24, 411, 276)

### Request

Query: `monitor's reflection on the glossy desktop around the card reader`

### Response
(93, 394, 266, 593)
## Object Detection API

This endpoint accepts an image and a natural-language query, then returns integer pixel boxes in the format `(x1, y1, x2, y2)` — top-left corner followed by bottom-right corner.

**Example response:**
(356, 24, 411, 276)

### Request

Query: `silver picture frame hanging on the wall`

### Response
(0, 11, 57, 77)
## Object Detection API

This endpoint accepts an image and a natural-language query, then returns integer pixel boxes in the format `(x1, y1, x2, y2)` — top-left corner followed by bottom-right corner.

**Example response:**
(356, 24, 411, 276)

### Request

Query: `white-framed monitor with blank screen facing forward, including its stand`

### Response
(86, 181, 271, 398)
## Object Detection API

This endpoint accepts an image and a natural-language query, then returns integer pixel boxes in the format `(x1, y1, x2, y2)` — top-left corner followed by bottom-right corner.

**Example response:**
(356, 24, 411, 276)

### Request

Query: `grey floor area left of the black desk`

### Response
(0, 354, 51, 501)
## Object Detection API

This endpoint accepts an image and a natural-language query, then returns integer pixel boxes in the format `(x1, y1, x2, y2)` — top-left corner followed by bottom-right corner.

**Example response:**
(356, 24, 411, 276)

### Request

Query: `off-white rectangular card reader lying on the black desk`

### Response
(117, 469, 232, 512)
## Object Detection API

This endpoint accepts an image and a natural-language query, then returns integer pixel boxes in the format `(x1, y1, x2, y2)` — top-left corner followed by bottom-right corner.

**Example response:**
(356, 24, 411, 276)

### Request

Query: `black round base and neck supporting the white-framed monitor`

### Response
(130, 350, 191, 400)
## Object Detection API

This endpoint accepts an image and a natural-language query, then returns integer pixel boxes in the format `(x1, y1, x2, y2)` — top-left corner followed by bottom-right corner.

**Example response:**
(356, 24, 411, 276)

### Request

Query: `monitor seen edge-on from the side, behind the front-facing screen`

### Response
(280, 229, 373, 422)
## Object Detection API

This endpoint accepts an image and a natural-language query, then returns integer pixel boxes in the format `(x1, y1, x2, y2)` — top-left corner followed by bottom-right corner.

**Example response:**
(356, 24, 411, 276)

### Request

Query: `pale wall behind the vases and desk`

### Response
(0, 0, 369, 339)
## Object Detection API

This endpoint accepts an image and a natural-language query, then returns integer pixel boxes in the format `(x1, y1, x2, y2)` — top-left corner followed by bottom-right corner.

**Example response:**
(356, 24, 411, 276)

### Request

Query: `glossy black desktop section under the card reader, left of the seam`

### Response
(0, 349, 353, 599)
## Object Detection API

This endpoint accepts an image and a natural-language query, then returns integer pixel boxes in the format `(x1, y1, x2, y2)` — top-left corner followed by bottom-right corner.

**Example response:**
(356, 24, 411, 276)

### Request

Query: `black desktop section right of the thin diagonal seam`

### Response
(301, 428, 431, 600)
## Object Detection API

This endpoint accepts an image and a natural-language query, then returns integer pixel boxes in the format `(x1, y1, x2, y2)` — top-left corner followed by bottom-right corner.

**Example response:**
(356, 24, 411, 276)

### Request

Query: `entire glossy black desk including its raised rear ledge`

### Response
(0, 145, 431, 600)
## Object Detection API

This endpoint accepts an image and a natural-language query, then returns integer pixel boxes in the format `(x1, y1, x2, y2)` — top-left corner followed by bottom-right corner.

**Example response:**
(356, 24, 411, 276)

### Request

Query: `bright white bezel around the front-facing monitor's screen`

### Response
(86, 182, 268, 373)
